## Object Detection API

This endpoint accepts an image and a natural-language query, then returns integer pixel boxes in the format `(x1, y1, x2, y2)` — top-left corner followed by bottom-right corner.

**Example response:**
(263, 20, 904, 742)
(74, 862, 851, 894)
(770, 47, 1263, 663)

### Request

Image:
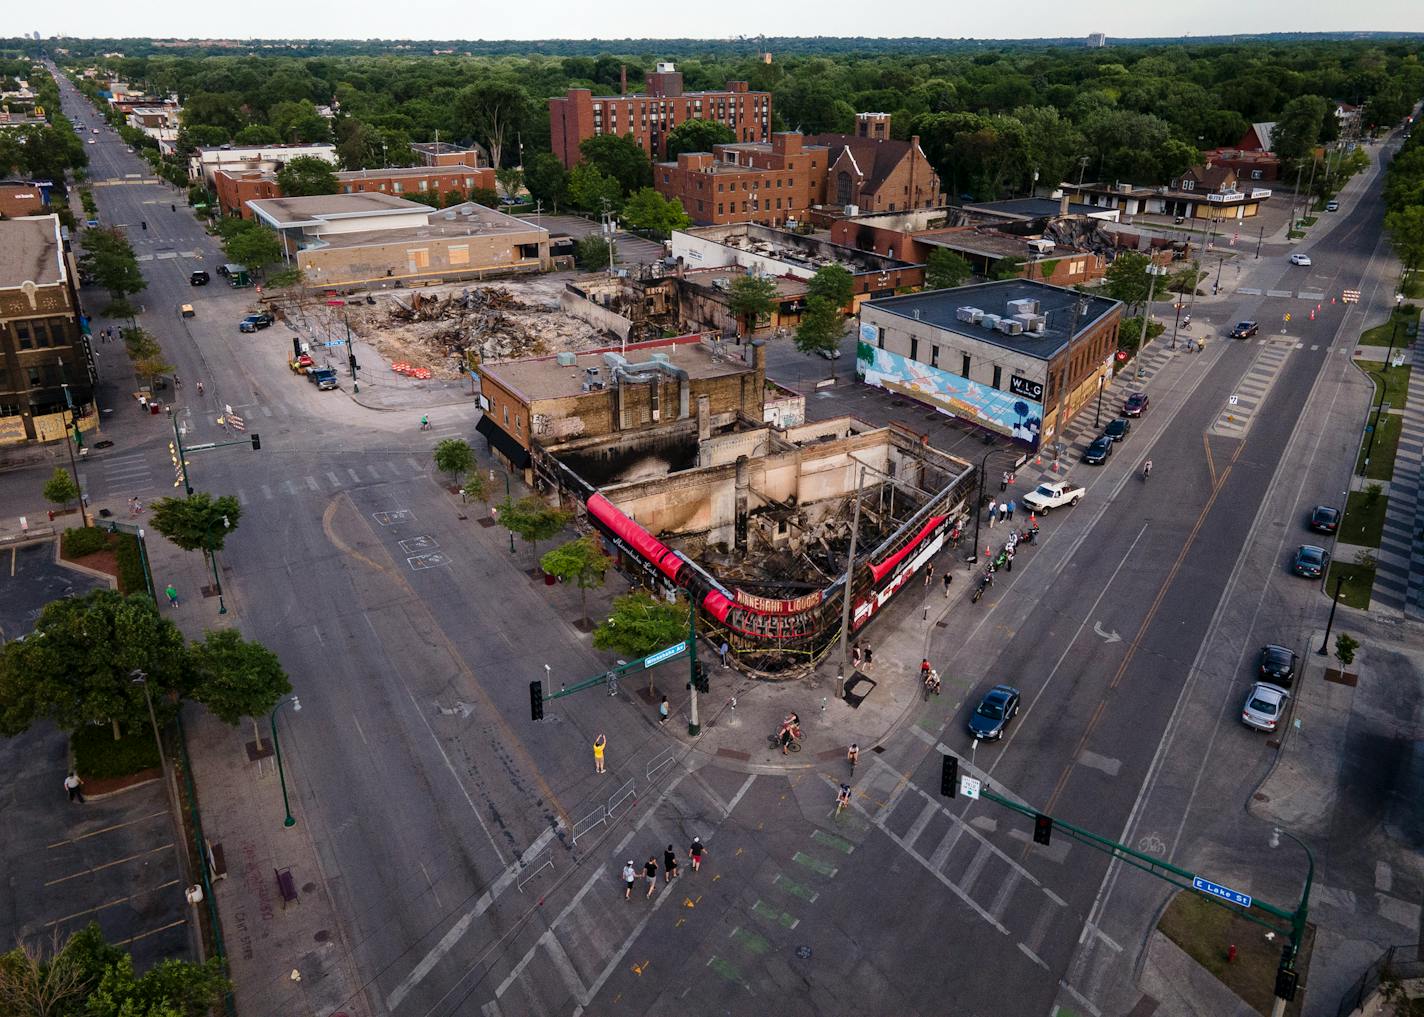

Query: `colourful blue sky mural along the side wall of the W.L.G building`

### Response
(856, 326, 1044, 446)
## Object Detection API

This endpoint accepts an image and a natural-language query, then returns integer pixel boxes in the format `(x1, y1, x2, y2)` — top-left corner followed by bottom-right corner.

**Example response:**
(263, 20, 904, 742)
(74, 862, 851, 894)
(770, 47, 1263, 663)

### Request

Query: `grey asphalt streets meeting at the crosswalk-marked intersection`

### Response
(44, 75, 1412, 1014)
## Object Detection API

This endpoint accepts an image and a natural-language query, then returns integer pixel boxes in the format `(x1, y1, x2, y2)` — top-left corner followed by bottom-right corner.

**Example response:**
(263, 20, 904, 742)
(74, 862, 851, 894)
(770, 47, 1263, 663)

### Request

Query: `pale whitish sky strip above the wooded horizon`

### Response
(30, 0, 1424, 40)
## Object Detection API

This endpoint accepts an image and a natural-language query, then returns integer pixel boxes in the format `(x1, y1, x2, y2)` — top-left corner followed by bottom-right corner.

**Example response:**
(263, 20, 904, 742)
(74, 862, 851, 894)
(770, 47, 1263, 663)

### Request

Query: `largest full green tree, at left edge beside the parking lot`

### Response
(0, 590, 188, 741)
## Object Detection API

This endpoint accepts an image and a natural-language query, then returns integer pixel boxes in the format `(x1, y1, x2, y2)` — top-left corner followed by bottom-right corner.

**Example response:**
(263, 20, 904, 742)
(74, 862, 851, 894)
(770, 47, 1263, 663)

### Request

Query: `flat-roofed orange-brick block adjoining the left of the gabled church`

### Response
(652, 132, 829, 226)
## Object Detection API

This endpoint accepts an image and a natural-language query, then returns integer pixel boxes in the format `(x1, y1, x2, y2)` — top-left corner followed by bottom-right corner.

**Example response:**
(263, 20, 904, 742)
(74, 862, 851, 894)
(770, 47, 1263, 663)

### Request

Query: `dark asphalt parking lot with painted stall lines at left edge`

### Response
(0, 543, 194, 970)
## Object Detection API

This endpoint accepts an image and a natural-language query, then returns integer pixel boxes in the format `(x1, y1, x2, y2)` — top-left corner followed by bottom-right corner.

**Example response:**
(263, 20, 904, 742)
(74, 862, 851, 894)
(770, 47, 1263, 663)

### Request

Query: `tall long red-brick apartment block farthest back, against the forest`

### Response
(548, 63, 772, 167)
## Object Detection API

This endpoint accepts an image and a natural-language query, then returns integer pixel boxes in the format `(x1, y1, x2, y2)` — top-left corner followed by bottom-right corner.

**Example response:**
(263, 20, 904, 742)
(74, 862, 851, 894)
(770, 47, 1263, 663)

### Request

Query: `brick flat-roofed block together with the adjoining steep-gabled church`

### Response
(654, 113, 944, 226)
